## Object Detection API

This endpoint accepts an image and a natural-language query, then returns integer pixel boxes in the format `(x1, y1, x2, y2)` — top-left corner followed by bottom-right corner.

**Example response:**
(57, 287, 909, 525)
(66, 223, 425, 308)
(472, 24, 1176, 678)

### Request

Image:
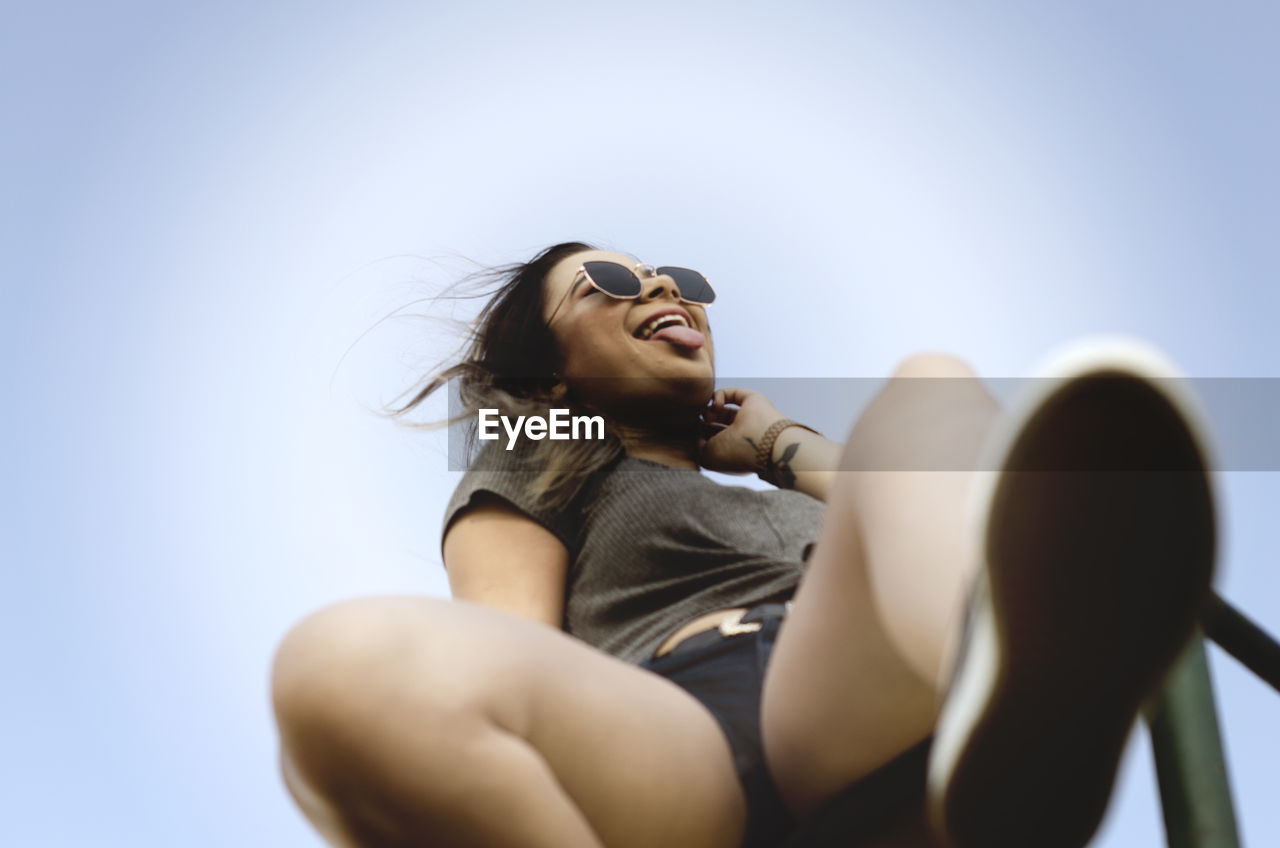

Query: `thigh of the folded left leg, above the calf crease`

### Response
(275, 597, 746, 848)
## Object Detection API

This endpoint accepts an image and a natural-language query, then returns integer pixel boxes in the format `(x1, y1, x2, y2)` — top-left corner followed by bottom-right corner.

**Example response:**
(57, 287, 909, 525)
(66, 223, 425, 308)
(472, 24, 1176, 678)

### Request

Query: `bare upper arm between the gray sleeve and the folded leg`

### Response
(444, 500, 568, 629)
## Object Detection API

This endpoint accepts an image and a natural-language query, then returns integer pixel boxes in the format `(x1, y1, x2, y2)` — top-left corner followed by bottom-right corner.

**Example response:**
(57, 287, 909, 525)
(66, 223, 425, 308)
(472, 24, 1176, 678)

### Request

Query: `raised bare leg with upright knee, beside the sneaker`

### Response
(762, 354, 1000, 813)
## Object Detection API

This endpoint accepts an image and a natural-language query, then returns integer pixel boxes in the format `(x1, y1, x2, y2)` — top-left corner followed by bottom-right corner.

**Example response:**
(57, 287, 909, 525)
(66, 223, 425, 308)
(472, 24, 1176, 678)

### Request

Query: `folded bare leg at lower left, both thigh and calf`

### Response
(273, 598, 746, 848)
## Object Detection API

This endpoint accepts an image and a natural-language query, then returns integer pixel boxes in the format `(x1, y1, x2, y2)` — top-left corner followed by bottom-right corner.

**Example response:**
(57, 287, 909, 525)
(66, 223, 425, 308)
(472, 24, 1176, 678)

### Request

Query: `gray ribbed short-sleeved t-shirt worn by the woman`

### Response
(442, 439, 826, 664)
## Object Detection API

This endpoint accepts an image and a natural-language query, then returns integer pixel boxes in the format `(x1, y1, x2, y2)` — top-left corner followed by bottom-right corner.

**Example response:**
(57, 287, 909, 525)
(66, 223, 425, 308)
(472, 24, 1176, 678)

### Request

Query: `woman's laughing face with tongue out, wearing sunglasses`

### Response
(543, 250, 716, 410)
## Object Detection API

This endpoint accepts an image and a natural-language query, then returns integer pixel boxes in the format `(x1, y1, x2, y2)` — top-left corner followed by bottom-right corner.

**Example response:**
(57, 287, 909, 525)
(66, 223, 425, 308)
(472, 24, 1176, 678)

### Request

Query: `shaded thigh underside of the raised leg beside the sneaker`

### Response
(760, 485, 937, 815)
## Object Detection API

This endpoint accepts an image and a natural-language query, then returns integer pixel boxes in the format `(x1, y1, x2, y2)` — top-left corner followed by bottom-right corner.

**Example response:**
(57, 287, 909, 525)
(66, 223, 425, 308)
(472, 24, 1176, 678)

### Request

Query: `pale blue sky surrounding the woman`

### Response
(0, 0, 1280, 848)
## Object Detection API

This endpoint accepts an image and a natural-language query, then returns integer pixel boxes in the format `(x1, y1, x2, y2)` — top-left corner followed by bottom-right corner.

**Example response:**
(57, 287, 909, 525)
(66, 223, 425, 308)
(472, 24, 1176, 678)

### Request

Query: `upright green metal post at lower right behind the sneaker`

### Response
(1146, 630, 1240, 848)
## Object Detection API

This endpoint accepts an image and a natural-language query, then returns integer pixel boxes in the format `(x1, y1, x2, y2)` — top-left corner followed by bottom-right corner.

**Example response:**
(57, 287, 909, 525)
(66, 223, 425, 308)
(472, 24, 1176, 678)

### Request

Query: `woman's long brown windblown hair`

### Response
(385, 241, 623, 509)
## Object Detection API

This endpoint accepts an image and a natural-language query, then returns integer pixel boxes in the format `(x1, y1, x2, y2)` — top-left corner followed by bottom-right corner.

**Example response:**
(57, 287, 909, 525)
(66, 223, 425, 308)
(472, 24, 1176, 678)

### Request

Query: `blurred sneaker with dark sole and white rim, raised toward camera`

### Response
(928, 337, 1216, 848)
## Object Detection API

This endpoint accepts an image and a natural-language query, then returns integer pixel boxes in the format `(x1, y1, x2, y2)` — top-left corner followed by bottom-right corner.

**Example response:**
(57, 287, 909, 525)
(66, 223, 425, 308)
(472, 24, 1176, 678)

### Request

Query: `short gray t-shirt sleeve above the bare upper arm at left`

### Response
(440, 439, 581, 556)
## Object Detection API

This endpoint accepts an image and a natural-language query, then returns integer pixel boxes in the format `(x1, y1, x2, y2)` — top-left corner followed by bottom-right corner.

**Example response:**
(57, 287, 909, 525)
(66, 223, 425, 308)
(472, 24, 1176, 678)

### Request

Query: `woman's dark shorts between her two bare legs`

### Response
(640, 605, 796, 848)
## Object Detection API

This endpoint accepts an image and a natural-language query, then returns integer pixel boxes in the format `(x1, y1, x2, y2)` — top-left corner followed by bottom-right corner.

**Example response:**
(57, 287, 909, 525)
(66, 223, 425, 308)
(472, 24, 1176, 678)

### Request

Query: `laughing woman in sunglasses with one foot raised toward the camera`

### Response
(273, 242, 1213, 848)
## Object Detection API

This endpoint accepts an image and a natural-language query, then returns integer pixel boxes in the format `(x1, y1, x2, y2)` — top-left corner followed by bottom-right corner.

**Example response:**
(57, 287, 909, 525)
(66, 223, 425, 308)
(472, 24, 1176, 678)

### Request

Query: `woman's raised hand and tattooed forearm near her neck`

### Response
(699, 388, 844, 501)
